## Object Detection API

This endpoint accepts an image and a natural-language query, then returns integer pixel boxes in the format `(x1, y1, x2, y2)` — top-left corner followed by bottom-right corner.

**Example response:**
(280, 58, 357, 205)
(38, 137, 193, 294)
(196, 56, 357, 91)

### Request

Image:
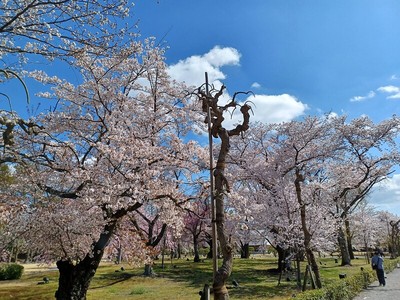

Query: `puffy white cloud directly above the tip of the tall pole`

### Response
(168, 46, 241, 86)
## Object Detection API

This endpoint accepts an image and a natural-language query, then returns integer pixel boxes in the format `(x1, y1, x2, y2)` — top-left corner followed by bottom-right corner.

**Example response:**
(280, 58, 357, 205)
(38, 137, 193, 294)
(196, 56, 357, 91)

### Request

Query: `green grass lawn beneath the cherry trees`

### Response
(0, 257, 369, 300)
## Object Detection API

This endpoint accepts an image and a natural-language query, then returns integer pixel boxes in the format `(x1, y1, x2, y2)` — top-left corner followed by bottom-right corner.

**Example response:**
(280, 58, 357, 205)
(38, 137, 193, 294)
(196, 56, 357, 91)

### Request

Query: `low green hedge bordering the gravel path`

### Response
(295, 259, 399, 300)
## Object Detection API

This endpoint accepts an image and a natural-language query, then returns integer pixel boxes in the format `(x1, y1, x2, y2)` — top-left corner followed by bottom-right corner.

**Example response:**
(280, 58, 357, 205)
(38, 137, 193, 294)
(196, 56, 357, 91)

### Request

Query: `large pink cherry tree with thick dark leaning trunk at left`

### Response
(6, 40, 205, 299)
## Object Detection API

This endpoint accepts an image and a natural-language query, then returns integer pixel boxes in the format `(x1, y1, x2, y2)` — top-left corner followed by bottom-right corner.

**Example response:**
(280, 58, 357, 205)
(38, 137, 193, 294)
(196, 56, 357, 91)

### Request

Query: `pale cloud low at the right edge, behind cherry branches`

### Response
(369, 174, 400, 216)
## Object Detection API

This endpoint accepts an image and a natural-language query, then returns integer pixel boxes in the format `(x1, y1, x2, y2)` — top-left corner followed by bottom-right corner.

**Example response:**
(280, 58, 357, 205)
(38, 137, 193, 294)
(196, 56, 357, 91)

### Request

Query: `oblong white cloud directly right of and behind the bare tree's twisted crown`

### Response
(224, 94, 308, 129)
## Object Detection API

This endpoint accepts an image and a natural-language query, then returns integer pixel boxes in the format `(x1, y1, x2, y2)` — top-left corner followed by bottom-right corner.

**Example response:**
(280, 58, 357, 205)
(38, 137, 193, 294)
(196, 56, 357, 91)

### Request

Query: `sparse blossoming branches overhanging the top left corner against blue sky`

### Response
(0, 0, 133, 68)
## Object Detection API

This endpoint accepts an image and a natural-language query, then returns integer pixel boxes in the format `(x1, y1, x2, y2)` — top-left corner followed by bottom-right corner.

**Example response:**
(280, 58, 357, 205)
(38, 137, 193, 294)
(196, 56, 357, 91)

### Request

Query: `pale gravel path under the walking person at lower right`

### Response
(353, 268, 400, 300)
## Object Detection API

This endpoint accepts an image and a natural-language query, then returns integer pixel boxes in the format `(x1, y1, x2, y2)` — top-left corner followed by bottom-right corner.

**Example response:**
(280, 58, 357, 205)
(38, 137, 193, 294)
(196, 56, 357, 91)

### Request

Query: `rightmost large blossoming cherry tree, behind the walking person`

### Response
(328, 116, 400, 265)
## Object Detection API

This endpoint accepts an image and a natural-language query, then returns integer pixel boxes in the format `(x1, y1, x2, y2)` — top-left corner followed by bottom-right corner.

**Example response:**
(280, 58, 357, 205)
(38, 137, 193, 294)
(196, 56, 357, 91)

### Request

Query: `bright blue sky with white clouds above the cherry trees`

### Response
(134, 0, 400, 216)
